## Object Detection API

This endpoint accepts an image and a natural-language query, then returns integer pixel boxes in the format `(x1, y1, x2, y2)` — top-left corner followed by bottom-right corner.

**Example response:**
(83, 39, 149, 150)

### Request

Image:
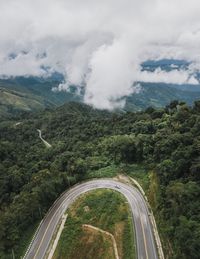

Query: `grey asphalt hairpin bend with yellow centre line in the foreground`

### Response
(24, 179, 158, 259)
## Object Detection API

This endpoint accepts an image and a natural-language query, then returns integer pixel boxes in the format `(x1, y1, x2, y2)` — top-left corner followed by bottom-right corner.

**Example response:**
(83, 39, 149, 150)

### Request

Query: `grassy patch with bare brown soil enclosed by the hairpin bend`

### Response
(53, 189, 135, 259)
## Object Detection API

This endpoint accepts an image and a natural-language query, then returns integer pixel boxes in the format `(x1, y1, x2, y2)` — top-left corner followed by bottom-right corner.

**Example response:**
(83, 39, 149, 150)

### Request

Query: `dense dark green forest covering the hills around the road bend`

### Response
(0, 101, 200, 259)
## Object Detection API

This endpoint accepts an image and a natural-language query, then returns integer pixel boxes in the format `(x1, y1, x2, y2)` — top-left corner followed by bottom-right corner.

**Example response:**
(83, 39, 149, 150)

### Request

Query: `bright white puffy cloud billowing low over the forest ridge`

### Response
(85, 38, 138, 109)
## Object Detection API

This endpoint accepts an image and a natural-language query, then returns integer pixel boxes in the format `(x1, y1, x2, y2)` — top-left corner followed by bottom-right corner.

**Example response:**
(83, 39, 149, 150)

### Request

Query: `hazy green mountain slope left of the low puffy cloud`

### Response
(0, 76, 81, 117)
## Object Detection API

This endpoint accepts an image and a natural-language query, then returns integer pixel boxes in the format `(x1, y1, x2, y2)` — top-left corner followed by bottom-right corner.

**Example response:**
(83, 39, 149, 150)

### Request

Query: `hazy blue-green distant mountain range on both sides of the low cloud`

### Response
(0, 73, 200, 117)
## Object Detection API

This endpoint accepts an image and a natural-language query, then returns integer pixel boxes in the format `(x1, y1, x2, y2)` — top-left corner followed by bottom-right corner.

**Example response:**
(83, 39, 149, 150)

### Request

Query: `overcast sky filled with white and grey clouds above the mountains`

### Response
(0, 0, 200, 109)
